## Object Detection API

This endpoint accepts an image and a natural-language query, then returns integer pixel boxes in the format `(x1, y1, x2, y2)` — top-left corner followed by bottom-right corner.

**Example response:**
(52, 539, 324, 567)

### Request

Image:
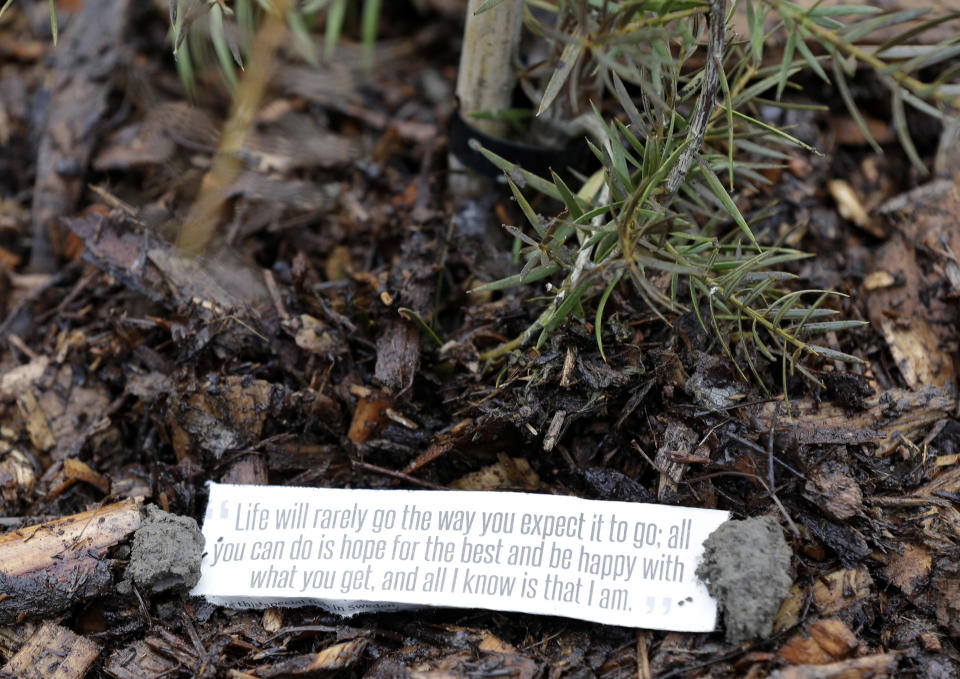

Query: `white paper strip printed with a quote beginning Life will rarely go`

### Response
(191, 483, 729, 632)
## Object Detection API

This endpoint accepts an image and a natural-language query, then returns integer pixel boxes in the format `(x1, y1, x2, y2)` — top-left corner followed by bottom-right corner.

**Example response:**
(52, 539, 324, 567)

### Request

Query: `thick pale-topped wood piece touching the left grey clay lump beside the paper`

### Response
(0, 500, 141, 624)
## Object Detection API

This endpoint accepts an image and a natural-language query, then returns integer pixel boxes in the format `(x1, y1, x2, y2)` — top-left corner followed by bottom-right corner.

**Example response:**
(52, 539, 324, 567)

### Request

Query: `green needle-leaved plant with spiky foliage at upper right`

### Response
(477, 0, 960, 388)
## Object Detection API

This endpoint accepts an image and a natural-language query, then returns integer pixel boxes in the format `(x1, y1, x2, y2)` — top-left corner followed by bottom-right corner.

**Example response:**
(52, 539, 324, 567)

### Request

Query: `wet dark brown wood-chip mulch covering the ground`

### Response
(0, 0, 960, 679)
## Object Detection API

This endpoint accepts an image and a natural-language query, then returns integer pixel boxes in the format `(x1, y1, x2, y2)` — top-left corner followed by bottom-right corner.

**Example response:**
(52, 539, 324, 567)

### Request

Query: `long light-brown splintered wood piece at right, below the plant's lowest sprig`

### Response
(758, 387, 957, 456)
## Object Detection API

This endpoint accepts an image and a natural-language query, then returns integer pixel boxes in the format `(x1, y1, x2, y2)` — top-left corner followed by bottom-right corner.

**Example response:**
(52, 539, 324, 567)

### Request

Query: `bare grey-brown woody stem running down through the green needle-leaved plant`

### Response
(667, 0, 727, 196)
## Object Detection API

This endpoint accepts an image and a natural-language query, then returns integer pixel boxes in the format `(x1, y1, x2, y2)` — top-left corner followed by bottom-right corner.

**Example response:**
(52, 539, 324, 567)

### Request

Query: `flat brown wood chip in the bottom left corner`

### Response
(0, 622, 100, 679)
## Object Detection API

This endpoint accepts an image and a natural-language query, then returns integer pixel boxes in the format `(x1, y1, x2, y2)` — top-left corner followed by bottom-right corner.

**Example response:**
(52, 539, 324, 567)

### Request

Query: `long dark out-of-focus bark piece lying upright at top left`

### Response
(30, 0, 130, 272)
